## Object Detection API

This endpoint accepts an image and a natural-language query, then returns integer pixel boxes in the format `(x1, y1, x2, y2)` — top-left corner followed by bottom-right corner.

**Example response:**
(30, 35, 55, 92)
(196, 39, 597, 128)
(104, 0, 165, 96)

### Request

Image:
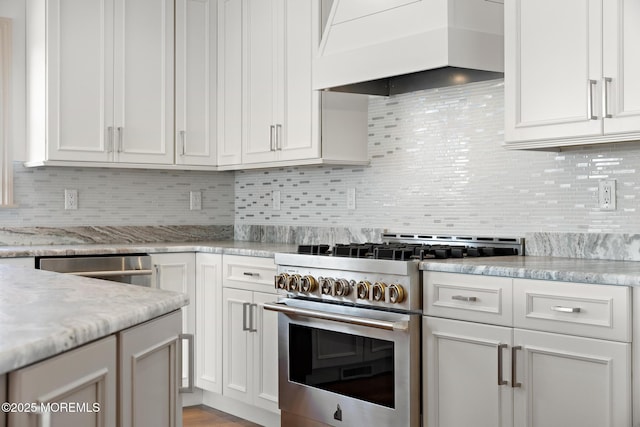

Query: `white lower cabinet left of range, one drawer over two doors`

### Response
(222, 255, 278, 413)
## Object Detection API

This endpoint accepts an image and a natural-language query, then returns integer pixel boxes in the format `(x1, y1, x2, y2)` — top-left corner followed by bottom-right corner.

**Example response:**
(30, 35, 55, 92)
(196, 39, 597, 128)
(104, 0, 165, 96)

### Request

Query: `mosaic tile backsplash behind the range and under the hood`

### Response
(235, 80, 640, 236)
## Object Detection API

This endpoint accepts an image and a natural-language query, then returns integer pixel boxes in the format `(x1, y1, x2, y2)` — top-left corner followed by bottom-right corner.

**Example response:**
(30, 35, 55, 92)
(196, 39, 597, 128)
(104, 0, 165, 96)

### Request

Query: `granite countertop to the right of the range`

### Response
(420, 255, 640, 286)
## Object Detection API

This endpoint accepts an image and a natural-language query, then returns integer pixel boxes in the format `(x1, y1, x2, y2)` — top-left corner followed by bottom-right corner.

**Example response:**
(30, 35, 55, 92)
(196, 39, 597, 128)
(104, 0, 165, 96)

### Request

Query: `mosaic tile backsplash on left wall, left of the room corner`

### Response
(0, 163, 234, 228)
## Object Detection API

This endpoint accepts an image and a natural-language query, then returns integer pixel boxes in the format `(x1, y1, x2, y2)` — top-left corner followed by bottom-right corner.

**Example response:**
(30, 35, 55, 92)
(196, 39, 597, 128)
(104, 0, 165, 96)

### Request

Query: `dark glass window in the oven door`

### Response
(289, 324, 395, 408)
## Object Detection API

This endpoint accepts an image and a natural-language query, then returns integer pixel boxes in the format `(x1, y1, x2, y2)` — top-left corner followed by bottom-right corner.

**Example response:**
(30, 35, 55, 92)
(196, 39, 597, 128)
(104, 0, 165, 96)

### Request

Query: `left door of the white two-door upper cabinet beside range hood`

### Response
(242, 0, 283, 163)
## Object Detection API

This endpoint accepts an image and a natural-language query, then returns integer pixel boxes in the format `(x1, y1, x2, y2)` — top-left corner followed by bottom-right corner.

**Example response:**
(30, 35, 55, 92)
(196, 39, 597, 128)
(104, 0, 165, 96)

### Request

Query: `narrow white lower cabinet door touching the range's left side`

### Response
(253, 292, 278, 412)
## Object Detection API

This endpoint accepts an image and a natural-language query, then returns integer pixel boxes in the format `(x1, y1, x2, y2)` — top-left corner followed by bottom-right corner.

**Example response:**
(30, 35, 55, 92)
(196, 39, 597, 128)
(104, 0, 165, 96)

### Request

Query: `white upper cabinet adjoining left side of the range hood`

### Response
(218, 0, 368, 169)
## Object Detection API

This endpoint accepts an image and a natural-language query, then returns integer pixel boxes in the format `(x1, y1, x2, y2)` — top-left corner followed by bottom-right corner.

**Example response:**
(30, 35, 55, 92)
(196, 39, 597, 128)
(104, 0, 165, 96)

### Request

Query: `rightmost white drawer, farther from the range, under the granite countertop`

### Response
(513, 279, 631, 342)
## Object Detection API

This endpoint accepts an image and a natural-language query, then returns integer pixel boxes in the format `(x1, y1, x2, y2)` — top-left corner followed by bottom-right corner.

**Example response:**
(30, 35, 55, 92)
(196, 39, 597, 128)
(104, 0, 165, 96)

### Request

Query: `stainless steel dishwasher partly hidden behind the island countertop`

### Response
(36, 254, 153, 287)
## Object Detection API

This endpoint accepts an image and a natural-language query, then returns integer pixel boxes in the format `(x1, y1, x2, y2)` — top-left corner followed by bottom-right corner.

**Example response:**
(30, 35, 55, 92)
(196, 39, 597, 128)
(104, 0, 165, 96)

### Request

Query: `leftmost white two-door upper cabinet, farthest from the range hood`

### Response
(27, 0, 174, 165)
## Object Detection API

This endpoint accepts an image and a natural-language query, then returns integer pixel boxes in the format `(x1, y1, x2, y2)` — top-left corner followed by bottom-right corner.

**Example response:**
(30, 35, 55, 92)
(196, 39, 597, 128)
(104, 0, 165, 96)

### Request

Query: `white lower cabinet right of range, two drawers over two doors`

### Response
(423, 272, 632, 427)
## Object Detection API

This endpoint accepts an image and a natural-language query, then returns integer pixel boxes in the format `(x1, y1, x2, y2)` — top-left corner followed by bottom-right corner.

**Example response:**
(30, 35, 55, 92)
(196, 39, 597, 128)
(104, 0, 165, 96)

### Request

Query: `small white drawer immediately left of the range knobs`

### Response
(222, 255, 276, 293)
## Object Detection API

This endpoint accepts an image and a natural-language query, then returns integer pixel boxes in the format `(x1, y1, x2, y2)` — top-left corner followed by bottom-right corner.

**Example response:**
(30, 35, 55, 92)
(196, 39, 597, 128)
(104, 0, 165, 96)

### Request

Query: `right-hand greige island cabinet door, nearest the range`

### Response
(120, 312, 182, 427)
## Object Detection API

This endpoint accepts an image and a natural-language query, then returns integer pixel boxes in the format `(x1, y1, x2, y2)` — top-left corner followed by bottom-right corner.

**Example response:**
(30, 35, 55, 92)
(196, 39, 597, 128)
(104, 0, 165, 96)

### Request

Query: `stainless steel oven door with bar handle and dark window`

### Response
(265, 299, 421, 427)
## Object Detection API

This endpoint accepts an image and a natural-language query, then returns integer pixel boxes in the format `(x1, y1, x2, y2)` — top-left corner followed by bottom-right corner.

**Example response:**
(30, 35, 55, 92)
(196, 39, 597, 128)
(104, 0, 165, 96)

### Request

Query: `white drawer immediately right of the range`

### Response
(423, 271, 512, 326)
